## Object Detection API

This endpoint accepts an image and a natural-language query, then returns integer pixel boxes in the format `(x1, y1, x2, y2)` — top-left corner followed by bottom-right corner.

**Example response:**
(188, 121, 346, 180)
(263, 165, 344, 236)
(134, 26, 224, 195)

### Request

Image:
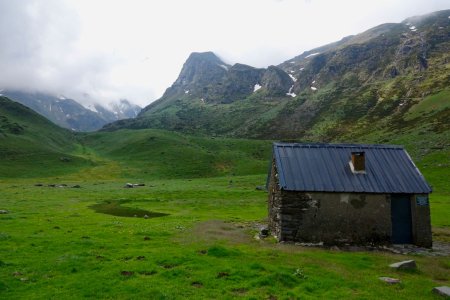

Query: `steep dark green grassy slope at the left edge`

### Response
(0, 97, 90, 177)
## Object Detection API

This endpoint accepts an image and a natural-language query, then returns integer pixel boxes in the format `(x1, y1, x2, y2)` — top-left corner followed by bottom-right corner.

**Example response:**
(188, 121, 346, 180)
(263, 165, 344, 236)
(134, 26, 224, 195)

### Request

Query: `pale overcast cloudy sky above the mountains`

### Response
(0, 0, 450, 106)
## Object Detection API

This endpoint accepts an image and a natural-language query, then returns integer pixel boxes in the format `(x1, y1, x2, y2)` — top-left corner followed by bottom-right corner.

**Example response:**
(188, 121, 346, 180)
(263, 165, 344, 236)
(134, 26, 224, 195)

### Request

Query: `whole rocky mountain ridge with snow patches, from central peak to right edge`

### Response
(103, 10, 450, 148)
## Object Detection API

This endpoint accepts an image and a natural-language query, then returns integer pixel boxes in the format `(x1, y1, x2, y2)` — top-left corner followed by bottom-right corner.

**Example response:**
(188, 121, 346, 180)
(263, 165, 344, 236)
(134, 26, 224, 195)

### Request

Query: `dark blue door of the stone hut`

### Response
(391, 195, 412, 244)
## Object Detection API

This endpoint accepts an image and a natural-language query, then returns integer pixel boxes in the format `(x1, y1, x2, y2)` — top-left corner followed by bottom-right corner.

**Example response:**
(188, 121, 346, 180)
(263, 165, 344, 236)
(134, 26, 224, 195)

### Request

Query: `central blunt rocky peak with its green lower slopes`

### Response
(104, 52, 294, 136)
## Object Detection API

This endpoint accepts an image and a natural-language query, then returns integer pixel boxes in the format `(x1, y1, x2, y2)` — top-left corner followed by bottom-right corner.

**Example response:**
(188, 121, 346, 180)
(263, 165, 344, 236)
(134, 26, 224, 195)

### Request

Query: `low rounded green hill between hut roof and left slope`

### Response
(81, 129, 271, 179)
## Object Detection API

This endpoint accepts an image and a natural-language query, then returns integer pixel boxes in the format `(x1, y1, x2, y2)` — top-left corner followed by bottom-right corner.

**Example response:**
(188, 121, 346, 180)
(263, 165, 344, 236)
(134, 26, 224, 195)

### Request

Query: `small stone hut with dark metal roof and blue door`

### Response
(267, 143, 432, 247)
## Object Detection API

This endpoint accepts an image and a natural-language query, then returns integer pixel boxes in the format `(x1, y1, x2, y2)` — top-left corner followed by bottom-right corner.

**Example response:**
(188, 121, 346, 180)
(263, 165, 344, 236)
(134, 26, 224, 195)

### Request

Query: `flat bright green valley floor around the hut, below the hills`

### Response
(0, 173, 450, 299)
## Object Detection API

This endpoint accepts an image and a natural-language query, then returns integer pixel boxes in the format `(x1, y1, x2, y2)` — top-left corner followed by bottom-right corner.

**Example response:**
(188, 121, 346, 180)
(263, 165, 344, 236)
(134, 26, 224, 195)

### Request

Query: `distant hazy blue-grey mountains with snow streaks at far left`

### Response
(2, 91, 141, 131)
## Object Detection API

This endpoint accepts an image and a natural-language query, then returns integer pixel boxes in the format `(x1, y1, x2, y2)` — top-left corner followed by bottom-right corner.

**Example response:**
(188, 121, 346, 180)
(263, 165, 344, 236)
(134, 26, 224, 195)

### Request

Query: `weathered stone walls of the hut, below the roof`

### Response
(268, 163, 431, 247)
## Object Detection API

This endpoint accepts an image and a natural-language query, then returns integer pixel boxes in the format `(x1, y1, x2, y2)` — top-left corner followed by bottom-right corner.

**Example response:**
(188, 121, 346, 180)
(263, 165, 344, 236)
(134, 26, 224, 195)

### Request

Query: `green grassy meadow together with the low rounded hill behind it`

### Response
(0, 126, 450, 299)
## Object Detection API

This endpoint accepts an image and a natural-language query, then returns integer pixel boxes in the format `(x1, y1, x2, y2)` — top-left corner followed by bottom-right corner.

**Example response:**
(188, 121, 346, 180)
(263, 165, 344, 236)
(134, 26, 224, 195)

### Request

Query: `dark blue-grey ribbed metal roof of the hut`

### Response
(273, 143, 431, 194)
